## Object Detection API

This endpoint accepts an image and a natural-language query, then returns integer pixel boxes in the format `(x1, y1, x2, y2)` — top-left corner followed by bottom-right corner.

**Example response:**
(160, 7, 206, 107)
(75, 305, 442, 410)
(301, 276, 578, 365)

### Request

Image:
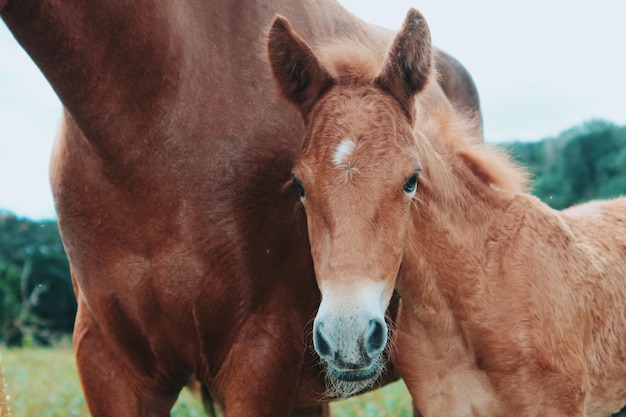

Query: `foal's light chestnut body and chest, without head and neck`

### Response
(396, 190, 626, 417)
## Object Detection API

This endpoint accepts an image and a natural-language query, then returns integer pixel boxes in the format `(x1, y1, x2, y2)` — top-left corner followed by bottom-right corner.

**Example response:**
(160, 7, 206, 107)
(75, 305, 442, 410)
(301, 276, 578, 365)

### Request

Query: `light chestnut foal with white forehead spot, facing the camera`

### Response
(269, 10, 626, 417)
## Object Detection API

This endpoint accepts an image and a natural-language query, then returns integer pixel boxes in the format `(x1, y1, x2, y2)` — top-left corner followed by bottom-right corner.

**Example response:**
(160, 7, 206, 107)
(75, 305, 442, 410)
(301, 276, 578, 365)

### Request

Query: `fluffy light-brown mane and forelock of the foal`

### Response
(315, 39, 530, 192)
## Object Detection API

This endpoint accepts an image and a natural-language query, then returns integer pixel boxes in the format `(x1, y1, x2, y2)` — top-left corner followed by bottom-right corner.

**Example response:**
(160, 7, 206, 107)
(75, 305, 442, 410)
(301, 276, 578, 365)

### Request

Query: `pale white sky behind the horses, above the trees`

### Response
(0, 0, 626, 218)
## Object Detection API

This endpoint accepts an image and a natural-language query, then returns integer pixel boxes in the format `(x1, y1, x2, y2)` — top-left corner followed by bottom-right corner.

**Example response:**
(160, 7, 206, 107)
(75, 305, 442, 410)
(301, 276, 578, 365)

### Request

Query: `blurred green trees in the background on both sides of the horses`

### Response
(0, 121, 626, 346)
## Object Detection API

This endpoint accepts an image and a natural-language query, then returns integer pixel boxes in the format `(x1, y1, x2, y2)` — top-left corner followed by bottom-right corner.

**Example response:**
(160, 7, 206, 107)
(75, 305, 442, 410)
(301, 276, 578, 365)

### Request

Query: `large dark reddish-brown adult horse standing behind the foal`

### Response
(0, 0, 478, 416)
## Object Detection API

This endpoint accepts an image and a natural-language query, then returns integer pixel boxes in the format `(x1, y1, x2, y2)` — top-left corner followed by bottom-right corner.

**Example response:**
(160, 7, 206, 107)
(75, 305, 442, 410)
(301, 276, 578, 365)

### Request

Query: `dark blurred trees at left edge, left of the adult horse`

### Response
(0, 212, 76, 346)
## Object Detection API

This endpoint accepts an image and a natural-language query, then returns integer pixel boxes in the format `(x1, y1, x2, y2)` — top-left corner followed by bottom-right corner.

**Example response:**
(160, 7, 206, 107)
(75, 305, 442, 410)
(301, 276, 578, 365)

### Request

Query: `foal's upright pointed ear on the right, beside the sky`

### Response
(376, 9, 432, 122)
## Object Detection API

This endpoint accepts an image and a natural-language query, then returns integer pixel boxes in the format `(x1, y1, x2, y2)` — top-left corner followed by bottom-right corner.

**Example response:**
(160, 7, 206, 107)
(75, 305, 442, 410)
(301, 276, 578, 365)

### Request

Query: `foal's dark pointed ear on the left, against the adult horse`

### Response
(267, 16, 335, 121)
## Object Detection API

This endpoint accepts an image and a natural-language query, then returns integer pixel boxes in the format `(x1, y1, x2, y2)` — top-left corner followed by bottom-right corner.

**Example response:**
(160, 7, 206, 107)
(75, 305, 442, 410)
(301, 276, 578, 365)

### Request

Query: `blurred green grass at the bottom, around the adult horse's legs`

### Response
(0, 349, 412, 417)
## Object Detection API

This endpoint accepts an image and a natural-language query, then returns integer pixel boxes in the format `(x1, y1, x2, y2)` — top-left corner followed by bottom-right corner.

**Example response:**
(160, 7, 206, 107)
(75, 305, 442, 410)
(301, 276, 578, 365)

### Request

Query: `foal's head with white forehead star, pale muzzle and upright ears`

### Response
(268, 10, 432, 395)
